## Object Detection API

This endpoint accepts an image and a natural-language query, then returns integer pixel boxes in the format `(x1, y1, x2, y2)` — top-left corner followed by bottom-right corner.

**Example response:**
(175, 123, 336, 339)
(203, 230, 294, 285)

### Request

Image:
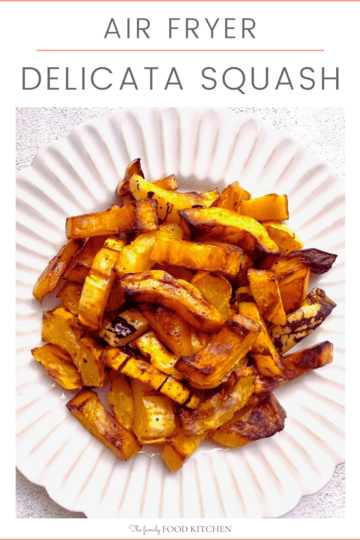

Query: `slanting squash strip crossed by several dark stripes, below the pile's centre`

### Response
(102, 347, 200, 409)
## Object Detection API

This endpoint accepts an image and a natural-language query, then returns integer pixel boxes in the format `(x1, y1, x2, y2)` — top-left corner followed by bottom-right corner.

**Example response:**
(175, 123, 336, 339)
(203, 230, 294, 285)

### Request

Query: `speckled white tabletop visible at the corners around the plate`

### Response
(16, 107, 345, 518)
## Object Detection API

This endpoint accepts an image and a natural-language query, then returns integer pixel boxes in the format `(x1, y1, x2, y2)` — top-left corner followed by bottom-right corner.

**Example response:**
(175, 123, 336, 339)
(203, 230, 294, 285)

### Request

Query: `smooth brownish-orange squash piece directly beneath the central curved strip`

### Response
(140, 303, 207, 357)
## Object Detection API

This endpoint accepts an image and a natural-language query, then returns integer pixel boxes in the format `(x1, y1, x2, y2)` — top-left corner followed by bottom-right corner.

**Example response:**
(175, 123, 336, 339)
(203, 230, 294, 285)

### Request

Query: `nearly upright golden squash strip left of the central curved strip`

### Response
(79, 237, 125, 330)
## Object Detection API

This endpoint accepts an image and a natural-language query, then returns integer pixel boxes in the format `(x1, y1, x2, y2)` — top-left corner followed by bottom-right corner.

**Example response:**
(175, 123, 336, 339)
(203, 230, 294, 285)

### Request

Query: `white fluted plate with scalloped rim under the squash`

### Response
(17, 109, 345, 518)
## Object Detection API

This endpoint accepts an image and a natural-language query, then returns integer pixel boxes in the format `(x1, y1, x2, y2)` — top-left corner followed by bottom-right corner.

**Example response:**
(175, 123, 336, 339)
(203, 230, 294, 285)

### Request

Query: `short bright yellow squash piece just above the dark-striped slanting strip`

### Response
(135, 330, 183, 380)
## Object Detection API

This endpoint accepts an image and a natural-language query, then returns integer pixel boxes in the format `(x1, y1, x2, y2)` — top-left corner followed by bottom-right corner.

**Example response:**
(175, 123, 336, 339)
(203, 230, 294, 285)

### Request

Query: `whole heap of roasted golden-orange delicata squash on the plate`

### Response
(32, 158, 336, 472)
